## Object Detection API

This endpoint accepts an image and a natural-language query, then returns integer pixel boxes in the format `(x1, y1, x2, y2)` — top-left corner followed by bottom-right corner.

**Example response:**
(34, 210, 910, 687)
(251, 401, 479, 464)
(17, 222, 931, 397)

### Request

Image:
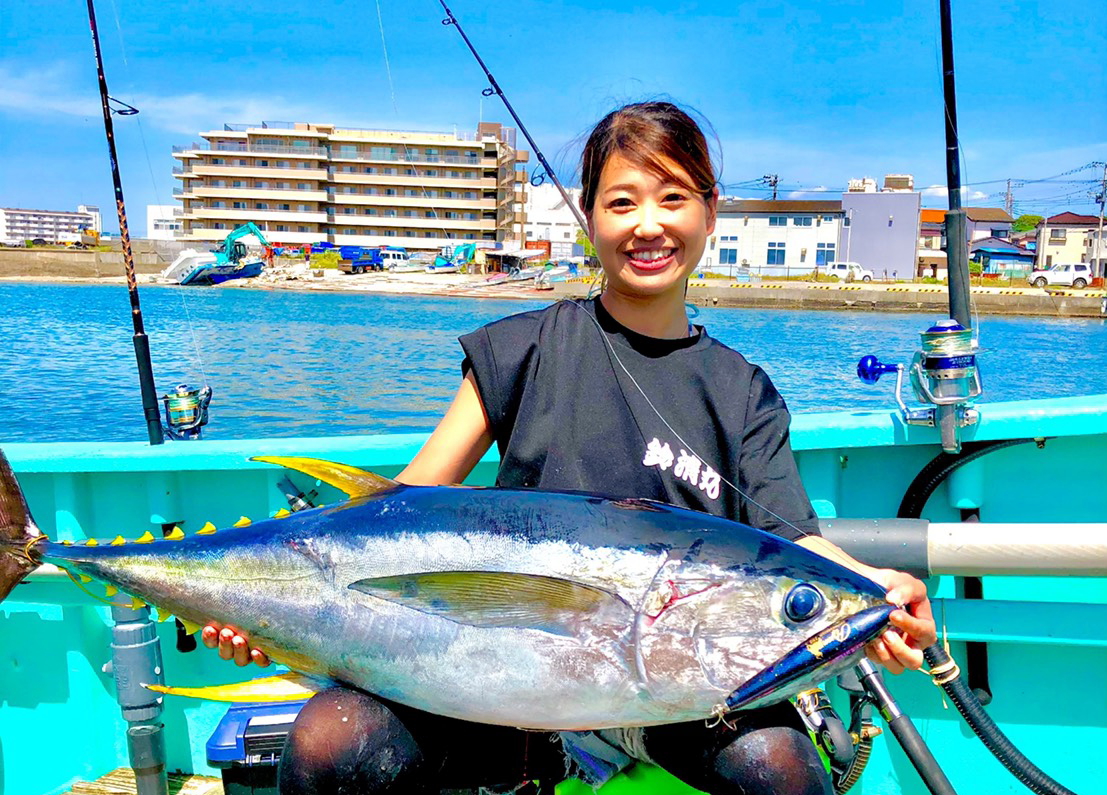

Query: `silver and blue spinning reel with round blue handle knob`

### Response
(857, 320, 983, 453)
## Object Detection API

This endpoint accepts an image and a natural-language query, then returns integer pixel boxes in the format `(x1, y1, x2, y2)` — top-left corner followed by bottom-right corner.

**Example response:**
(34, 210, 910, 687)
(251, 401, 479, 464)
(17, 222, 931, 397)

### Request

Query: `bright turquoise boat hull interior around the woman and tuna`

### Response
(0, 395, 1107, 795)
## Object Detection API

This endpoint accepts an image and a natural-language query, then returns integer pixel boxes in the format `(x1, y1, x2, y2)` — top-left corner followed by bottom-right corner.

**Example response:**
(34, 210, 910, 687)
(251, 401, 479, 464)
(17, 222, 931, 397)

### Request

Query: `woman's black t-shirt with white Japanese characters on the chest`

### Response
(461, 299, 818, 539)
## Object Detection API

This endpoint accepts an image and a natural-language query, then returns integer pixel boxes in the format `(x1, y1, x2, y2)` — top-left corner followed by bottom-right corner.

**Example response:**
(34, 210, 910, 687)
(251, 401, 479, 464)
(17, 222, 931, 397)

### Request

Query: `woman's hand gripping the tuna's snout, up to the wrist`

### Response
(865, 569, 938, 673)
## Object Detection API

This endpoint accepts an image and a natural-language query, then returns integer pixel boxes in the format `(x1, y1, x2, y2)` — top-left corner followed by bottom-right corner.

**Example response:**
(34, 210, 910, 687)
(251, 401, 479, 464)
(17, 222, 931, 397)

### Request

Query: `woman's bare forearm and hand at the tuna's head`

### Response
(796, 536, 938, 673)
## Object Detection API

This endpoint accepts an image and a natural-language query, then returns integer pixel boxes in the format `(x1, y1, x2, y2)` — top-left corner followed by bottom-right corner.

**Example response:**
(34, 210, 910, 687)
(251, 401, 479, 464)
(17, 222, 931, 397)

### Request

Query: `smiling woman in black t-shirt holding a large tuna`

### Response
(204, 103, 934, 795)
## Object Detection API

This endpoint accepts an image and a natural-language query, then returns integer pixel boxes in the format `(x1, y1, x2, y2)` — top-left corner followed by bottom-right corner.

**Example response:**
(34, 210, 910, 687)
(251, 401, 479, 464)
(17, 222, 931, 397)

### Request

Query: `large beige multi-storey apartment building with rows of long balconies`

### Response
(173, 122, 528, 250)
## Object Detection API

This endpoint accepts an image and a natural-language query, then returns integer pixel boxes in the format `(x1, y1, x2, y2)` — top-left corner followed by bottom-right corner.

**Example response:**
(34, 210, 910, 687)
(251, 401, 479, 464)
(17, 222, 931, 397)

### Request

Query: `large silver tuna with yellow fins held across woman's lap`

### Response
(0, 454, 893, 730)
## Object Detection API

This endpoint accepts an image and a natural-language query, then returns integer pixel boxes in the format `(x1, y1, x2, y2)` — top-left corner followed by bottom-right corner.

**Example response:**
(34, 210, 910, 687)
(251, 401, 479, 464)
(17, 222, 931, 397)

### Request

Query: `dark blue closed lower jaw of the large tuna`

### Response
(725, 605, 898, 712)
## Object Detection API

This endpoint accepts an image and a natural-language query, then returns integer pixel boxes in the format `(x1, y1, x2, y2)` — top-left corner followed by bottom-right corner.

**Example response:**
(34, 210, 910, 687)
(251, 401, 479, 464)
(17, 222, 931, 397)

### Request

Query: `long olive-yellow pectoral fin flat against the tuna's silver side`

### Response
(350, 571, 633, 636)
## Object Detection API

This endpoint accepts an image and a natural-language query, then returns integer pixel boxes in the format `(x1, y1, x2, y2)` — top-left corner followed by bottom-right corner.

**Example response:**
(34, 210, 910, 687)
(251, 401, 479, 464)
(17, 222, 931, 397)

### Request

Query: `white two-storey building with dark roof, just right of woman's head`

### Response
(702, 199, 845, 276)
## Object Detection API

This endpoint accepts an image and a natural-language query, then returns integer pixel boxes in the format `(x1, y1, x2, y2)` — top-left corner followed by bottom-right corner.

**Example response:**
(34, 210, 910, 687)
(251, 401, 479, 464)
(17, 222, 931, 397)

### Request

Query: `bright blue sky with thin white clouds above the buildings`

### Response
(0, 0, 1107, 235)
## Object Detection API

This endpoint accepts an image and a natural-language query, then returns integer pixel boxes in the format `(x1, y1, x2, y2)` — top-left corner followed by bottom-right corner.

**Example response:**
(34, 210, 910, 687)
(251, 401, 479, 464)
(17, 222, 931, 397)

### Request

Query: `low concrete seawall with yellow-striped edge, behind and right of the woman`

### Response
(554, 280, 1107, 318)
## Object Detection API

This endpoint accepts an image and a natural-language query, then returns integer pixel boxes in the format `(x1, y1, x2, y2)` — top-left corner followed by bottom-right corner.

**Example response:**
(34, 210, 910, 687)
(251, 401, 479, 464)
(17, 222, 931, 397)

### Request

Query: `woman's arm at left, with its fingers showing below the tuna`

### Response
(200, 370, 492, 668)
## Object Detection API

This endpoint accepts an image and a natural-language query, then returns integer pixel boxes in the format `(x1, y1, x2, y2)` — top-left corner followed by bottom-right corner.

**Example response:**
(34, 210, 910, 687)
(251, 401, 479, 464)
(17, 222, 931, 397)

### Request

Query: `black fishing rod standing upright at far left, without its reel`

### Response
(87, 0, 165, 445)
